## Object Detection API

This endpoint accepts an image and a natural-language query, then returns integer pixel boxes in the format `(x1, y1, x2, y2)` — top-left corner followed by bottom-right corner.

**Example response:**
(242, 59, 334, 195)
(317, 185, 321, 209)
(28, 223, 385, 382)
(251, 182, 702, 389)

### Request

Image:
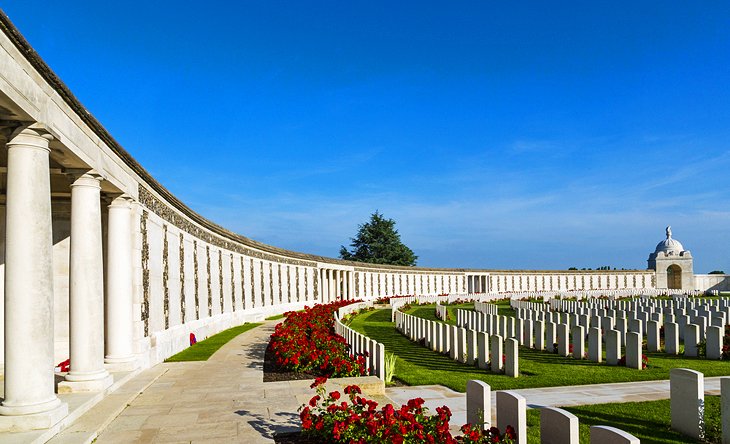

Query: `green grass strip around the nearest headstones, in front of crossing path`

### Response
(527, 396, 722, 444)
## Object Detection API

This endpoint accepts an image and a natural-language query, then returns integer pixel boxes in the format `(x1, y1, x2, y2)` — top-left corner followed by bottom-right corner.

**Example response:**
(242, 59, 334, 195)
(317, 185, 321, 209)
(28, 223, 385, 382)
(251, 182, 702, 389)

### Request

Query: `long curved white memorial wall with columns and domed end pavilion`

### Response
(0, 7, 725, 438)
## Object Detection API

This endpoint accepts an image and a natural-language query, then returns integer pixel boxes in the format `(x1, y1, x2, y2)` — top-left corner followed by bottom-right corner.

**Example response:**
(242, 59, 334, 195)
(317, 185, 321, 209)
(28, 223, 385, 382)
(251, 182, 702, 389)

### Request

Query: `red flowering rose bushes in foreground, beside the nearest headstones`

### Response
(299, 378, 515, 444)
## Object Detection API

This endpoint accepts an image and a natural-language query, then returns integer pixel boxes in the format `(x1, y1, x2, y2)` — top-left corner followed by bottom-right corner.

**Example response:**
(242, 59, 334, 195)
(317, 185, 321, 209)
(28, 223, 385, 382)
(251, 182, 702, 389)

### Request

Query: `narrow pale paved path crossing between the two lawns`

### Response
(385, 376, 722, 424)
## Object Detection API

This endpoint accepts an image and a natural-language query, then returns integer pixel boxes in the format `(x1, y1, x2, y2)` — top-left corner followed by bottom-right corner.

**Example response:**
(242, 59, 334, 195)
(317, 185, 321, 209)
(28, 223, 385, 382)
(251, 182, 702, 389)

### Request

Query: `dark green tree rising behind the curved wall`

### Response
(340, 211, 418, 266)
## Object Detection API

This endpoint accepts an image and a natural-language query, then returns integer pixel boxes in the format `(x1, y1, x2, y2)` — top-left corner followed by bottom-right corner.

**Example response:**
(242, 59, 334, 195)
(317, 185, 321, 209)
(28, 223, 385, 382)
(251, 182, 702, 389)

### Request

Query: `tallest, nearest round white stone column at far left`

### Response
(0, 127, 68, 424)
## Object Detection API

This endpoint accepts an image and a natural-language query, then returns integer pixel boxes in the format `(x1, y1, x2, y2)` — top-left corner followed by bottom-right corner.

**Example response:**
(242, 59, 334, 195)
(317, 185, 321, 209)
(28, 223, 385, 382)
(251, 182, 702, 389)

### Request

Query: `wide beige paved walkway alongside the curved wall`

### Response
(50, 321, 313, 443)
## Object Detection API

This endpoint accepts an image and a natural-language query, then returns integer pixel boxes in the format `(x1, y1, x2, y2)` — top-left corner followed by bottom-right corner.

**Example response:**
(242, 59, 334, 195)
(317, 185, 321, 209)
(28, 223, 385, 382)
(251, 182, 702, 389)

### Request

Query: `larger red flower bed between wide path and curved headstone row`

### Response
(269, 301, 368, 377)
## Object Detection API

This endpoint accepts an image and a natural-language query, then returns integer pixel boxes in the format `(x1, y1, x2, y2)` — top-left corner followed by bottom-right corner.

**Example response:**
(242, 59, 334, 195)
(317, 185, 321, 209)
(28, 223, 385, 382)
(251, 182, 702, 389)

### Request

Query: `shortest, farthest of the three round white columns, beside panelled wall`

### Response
(104, 195, 137, 371)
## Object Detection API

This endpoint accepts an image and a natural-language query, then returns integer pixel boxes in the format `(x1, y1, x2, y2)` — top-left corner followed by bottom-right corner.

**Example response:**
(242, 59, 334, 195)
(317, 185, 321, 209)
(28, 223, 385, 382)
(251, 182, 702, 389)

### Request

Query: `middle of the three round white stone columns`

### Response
(58, 171, 113, 392)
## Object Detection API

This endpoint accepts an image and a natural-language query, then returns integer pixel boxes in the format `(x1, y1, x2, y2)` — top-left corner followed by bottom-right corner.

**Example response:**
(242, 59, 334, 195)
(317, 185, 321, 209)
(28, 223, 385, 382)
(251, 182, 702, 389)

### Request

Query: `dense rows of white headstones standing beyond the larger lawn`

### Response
(395, 298, 730, 376)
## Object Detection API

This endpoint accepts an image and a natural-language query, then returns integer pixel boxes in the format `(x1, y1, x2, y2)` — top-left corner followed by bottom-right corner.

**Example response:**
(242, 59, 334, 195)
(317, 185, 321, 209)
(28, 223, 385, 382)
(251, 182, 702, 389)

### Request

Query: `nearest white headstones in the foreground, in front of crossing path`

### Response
(466, 368, 730, 444)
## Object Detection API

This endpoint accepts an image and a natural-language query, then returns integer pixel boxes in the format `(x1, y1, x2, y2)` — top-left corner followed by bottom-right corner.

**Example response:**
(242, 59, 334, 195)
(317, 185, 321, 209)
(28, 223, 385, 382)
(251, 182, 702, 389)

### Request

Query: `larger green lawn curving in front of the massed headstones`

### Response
(350, 306, 730, 392)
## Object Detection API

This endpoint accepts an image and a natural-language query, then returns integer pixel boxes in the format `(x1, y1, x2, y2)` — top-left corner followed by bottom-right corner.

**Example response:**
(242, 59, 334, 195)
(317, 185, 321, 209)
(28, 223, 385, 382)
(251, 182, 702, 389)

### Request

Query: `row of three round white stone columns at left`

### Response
(0, 124, 135, 427)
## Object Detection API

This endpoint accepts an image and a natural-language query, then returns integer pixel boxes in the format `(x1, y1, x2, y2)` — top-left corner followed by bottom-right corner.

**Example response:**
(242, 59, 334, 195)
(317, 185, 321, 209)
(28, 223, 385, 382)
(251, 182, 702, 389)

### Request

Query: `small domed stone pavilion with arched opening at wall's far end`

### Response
(647, 226, 694, 290)
